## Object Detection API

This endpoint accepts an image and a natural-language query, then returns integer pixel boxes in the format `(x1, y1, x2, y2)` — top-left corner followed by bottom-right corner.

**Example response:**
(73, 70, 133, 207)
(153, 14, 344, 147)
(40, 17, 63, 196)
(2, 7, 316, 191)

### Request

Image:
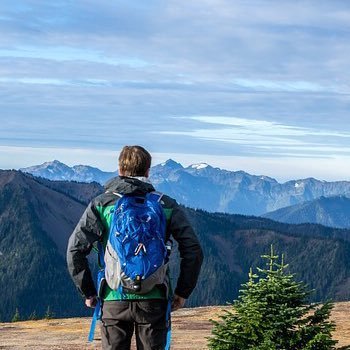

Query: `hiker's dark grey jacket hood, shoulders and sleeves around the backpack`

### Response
(67, 177, 203, 299)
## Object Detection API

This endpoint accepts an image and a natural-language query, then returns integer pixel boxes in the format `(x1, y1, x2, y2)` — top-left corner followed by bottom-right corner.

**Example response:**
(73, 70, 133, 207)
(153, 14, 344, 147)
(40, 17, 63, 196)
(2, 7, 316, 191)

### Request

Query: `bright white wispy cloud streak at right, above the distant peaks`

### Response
(162, 116, 350, 158)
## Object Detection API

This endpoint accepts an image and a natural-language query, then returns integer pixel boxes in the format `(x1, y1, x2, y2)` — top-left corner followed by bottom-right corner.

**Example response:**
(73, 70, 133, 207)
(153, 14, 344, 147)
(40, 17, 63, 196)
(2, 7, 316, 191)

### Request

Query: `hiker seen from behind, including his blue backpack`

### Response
(67, 146, 203, 350)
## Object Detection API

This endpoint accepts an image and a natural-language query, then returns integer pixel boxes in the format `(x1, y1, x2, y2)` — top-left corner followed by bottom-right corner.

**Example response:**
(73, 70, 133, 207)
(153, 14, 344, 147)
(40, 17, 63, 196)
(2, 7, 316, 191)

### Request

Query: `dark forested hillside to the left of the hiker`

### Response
(0, 172, 89, 320)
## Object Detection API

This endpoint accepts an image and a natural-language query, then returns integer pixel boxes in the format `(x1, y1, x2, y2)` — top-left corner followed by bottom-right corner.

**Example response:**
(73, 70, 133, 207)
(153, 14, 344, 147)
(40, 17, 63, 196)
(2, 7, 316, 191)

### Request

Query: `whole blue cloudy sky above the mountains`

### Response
(0, 0, 350, 181)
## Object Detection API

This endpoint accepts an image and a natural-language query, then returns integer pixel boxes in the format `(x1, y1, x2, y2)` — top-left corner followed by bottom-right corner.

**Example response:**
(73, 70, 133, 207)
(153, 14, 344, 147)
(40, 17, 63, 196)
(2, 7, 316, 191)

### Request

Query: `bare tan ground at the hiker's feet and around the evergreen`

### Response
(0, 302, 350, 350)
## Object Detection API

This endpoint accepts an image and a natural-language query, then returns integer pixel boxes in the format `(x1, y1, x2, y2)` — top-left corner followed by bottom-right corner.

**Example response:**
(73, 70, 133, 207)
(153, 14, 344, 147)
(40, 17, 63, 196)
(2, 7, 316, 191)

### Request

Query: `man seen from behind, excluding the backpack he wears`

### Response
(67, 146, 203, 350)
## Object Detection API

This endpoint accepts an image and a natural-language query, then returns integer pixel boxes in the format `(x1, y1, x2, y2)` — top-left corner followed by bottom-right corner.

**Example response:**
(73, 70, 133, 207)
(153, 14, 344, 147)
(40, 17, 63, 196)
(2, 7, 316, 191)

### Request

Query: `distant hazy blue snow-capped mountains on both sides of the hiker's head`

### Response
(21, 159, 350, 215)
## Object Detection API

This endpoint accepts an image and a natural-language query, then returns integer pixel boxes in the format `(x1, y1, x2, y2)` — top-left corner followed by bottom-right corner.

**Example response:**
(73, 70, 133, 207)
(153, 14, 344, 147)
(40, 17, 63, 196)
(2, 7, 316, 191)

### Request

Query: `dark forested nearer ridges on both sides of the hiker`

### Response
(0, 171, 350, 320)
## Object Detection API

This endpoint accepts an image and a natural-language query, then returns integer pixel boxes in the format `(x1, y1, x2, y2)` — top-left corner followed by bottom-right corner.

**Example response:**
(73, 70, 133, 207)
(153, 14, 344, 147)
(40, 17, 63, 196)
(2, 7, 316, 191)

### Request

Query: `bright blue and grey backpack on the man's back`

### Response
(104, 192, 168, 294)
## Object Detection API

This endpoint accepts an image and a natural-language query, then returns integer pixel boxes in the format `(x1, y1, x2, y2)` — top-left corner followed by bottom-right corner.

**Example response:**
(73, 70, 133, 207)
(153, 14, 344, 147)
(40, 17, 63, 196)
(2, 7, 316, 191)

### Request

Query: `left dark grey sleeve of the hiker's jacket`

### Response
(67, 203, 102, 298)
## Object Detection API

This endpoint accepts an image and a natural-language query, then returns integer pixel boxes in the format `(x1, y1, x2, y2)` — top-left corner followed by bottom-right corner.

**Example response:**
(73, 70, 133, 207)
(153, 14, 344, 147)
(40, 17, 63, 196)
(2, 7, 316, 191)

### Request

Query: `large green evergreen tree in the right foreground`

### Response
(208, 246, 337, 350)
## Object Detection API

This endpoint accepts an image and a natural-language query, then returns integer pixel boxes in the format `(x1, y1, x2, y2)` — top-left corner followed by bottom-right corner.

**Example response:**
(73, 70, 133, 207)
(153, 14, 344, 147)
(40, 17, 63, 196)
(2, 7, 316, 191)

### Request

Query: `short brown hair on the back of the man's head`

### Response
(119, 146, 152, 176)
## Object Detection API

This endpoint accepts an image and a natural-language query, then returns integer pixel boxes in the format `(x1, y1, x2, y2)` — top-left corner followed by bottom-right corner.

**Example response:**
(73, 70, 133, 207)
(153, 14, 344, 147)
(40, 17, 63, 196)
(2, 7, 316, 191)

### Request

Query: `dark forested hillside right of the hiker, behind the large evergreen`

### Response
(188, 209, 350, 306)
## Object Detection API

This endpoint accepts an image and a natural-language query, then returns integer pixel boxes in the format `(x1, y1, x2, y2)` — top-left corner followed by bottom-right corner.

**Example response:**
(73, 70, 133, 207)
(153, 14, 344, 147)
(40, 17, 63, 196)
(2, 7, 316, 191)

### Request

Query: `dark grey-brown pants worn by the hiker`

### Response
(101, 300, 167, 350)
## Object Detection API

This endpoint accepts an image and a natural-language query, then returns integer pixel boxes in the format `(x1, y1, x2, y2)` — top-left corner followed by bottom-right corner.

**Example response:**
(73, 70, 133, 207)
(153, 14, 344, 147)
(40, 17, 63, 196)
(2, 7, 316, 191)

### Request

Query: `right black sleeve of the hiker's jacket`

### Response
(169, 204, 203, 299)
